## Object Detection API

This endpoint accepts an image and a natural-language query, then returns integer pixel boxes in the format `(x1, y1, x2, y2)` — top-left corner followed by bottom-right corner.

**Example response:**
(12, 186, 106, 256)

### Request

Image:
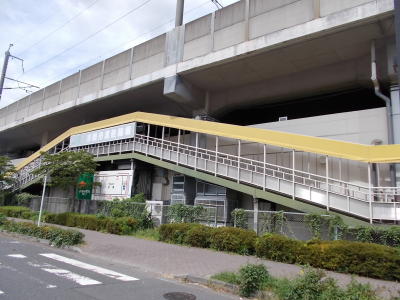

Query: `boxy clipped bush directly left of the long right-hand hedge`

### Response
(210, 227, 257, 255)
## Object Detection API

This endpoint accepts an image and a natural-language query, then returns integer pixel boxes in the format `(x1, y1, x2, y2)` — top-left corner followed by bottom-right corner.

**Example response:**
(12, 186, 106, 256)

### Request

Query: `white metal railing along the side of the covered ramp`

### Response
(15, 134, 400, 221)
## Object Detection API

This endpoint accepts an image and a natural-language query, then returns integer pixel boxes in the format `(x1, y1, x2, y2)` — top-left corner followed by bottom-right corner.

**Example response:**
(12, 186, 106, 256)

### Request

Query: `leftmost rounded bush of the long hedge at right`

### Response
(256, 233, 307, 264)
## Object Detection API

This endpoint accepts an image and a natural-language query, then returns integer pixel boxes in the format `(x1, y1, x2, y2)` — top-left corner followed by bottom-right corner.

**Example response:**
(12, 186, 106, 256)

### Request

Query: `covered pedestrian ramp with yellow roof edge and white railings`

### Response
(17, 112, 400, 223)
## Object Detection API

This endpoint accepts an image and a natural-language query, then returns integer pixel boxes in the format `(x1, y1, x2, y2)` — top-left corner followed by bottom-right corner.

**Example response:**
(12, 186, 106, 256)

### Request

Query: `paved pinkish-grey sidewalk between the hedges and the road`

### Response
(7, 219, 400, 298)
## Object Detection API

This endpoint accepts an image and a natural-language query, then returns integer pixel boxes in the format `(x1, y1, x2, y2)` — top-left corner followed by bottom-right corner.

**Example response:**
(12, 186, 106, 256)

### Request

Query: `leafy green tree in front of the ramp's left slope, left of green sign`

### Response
(33, 151, 97, 211)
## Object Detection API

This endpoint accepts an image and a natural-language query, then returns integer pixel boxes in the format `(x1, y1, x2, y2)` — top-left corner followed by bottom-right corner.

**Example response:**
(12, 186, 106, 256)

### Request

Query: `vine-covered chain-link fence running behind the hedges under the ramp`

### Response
(5, 197, 400, 247)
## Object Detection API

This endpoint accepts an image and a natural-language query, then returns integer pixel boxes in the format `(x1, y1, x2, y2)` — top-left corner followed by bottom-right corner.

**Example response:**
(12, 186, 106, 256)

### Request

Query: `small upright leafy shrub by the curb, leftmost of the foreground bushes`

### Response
(239, 264, 269, 297)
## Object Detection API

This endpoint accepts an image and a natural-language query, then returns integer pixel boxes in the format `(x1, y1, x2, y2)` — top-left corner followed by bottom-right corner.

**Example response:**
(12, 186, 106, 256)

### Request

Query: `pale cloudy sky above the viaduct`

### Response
(0, 0, 237, 108)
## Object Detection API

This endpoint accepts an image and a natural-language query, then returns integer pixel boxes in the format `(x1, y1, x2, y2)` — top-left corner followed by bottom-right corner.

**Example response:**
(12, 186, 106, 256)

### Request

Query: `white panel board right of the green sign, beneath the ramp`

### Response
(92, 170, 133, 200)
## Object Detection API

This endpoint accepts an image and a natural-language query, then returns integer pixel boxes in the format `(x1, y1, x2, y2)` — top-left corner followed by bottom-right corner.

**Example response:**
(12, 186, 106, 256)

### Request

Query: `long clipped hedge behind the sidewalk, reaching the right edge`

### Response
(256, 234, 400, 280)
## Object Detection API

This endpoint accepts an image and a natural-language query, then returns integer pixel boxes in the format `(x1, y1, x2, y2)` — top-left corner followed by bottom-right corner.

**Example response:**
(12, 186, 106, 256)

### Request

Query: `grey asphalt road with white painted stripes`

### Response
(0, 235, 238, 300)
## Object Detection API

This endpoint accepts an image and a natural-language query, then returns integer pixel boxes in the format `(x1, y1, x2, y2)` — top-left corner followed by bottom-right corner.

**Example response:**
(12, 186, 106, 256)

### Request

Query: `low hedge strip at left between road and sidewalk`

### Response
(2, 221, 84, 247)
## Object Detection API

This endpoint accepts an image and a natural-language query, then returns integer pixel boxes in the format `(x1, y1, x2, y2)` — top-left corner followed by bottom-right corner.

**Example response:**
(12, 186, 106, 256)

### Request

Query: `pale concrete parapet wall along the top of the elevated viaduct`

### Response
(0, 0, 390, 130)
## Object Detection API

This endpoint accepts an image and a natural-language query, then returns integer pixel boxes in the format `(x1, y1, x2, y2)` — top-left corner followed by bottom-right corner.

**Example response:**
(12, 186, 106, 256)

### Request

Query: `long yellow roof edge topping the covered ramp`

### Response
(16, 112, 400, 170)
